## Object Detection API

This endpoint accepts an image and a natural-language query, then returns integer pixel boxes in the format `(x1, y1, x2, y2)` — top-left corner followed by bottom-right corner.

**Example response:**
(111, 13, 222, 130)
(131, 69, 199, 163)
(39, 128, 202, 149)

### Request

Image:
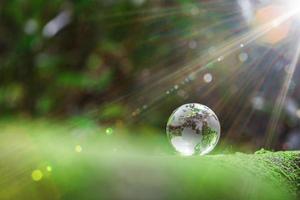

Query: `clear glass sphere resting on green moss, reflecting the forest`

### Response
(166, 103, 221, 156)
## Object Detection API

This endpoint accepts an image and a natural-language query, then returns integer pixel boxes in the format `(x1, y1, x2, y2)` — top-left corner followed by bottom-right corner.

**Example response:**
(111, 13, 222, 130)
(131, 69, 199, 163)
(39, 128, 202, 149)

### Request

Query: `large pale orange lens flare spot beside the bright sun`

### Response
(254, 5, 291, 44)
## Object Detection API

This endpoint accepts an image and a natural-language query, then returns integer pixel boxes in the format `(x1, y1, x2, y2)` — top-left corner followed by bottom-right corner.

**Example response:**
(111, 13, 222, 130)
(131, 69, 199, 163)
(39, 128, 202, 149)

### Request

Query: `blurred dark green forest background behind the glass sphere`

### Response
(0, 0, 300, 150)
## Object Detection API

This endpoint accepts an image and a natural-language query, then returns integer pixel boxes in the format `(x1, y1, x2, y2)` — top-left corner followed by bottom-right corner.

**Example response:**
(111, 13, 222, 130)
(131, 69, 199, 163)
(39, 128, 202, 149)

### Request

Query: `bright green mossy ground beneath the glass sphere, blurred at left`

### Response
(0, 121, 300, 200)
